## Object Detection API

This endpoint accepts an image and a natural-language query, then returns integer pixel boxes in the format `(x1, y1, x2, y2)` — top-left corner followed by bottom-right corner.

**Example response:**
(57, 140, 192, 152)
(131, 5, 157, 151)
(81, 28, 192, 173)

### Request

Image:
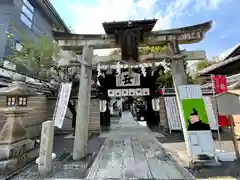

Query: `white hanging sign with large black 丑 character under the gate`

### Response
(116, 72, 140, 87)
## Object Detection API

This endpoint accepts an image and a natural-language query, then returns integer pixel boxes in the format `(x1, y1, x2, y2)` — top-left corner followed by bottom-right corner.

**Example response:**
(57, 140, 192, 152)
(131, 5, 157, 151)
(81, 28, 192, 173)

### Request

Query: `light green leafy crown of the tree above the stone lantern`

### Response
(4, 26, 60, 80)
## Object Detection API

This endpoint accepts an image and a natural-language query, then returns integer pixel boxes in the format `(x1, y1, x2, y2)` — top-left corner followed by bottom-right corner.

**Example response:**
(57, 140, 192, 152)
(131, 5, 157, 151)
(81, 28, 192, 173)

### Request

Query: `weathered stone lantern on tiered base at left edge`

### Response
(0, 76, 38, 175)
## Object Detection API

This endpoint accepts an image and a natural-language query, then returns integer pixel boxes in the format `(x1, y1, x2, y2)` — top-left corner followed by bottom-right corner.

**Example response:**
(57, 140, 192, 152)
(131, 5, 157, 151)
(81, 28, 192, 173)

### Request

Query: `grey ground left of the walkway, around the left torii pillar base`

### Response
(8, 134, 105, 180)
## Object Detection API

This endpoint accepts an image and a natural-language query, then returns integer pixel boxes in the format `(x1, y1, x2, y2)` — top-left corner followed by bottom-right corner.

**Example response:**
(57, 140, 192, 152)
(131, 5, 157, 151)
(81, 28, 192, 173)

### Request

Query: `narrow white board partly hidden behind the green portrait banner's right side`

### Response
(203, 96, 218, 130)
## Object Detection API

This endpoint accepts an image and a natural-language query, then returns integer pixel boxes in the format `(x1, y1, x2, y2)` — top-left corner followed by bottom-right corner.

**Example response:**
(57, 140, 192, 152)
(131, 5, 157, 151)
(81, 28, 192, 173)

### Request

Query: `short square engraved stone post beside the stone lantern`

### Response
(38, 121, 54, 177)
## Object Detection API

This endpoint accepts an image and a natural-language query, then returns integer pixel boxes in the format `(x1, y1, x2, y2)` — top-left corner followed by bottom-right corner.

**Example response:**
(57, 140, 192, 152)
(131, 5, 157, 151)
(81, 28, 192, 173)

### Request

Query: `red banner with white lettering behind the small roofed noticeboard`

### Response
(212, 75, 230, 127)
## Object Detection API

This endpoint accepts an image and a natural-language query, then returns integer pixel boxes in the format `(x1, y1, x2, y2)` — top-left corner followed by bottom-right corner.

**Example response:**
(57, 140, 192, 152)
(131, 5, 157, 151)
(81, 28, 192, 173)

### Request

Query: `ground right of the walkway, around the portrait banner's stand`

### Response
(158, 132, 240, 180)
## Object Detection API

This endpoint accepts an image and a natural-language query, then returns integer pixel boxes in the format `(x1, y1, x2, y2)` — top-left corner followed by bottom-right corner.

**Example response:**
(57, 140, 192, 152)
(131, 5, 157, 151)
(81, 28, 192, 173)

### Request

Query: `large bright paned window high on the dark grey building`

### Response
(21, 0, 34, 28)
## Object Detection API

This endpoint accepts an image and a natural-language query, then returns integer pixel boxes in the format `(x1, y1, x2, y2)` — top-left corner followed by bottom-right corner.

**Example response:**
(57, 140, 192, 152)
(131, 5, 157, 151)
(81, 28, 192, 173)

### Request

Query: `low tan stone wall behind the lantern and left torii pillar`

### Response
(0, 95, 100, 138)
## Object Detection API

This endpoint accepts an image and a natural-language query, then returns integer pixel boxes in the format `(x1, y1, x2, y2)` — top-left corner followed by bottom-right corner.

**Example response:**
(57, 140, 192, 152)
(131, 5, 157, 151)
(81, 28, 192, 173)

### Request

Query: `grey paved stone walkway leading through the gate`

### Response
(86, 112, 194, 180)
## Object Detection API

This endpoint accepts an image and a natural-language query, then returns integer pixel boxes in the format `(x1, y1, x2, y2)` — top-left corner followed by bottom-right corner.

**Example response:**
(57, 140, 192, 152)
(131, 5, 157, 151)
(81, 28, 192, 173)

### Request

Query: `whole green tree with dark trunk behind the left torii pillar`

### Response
(4, 29, 79, 129)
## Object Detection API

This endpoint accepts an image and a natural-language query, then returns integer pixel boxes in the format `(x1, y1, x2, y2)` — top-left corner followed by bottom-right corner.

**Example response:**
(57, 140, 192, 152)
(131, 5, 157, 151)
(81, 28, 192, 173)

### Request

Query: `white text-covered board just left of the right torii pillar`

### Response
(164, 97, 182, 131)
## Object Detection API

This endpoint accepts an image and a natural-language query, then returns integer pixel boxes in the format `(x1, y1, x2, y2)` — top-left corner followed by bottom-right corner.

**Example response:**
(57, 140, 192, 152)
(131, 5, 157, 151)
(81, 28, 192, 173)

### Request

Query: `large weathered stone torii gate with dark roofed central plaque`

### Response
(54, 19, 212, 160)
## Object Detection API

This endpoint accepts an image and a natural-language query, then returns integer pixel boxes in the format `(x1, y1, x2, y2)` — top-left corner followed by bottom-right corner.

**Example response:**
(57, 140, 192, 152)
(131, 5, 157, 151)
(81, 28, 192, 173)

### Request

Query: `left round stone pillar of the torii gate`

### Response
(73, 45, 93, 160)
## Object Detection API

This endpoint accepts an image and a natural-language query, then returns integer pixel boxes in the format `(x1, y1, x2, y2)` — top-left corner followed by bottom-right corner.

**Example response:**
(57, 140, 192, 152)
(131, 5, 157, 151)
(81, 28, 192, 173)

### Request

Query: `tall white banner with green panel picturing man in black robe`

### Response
(179, 85, 215, 156)
